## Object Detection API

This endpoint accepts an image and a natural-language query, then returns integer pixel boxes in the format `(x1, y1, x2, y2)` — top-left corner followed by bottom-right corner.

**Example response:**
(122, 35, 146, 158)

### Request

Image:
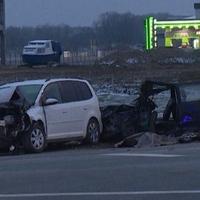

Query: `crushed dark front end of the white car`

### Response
(0, 85, 41, 149)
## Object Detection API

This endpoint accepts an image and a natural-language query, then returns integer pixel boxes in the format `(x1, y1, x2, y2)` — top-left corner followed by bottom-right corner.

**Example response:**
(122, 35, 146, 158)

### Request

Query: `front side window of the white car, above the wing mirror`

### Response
(43, 83, 62, 103)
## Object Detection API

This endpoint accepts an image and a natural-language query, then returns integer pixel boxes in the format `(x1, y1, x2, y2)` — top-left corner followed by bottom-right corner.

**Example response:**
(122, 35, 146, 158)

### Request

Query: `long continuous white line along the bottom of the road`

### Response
(0, 190, 200, 198)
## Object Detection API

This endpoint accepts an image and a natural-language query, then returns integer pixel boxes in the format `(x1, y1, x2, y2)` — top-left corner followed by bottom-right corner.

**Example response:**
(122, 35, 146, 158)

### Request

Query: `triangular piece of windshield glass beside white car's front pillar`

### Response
(17, 84, 42, 105)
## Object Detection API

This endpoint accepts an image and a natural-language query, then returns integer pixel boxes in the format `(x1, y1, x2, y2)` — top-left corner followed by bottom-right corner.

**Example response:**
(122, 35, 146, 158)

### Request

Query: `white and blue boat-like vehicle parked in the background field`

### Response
(22, 40, 62, 65)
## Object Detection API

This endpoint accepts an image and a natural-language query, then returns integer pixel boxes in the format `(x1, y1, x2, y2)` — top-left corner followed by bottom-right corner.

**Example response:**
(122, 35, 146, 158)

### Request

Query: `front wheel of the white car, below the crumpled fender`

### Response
(24, 123, 46, 153)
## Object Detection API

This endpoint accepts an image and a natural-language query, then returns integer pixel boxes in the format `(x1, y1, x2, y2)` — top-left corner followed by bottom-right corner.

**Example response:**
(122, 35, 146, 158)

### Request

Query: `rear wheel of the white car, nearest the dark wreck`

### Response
(85, 118, 100, 144)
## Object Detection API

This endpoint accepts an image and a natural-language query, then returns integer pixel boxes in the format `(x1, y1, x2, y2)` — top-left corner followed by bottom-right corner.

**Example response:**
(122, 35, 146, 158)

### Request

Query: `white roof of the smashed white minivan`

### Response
(0, 78, 87, 88)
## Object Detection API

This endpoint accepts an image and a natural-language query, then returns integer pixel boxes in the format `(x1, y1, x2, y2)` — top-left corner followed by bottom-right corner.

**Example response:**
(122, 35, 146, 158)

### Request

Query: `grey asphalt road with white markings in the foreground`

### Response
(0, 143, 200, 200)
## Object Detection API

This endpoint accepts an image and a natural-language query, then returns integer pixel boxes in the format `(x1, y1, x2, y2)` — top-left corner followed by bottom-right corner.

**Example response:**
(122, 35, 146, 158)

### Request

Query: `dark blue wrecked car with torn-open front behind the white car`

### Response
(101, 81, 200, 145)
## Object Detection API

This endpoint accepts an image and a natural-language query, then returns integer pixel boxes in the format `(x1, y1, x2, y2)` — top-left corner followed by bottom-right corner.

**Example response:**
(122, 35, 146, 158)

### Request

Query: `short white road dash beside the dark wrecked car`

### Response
(104, 153, 183, 158)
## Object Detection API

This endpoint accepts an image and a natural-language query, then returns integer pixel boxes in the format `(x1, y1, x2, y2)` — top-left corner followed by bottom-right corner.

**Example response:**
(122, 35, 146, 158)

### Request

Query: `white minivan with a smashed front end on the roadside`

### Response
(0, 79, 102, 153)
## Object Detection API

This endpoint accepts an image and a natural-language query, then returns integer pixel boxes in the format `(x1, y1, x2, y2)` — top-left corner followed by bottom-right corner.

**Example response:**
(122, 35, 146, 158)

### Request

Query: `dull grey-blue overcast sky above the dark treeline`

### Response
(5, 0, 200, 26)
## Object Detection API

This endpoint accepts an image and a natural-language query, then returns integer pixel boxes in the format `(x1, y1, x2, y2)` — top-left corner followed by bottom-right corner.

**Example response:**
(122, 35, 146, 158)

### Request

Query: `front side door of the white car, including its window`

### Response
(43, 82, 70, 139)
